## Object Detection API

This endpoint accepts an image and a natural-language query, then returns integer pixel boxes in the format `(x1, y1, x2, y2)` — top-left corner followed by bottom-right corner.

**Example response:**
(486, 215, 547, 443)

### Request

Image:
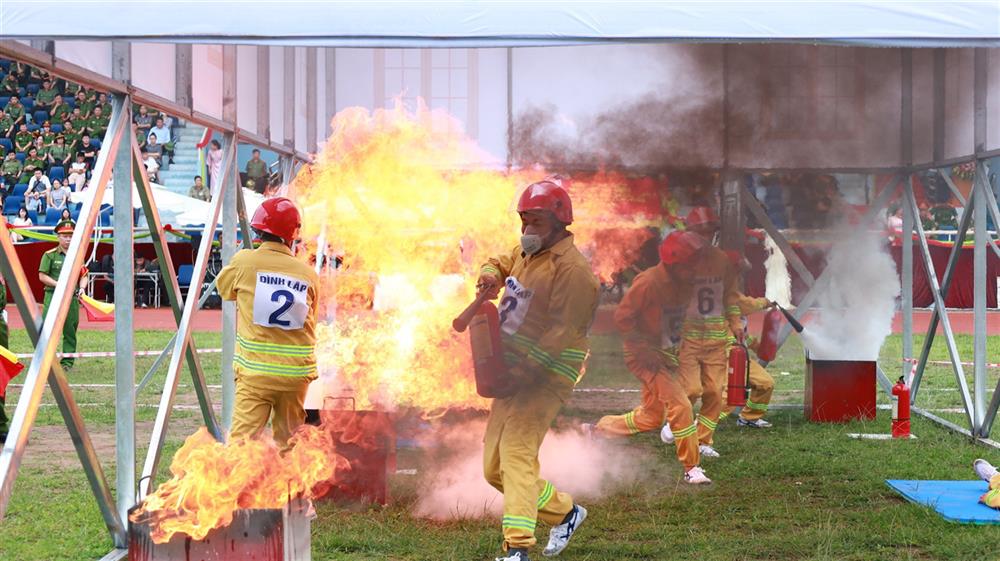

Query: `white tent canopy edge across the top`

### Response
(0, 0, 1000, 47)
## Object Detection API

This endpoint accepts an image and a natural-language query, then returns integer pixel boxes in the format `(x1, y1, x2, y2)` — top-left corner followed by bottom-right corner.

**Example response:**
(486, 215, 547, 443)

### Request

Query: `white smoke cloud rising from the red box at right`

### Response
(802, 224, 900, 360)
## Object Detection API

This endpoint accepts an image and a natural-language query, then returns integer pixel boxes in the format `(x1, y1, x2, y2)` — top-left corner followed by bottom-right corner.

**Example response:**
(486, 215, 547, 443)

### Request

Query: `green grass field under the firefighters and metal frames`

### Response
(0, 326, 1000, 561)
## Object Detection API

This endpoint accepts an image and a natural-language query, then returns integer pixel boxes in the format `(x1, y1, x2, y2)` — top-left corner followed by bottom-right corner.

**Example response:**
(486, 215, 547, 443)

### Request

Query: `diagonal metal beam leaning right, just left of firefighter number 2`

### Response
(135, 133, 237, 494)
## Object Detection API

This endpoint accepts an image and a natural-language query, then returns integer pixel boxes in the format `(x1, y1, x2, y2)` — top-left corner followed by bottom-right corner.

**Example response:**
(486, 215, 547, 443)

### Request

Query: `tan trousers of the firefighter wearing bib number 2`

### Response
(229, 377, 309, 447)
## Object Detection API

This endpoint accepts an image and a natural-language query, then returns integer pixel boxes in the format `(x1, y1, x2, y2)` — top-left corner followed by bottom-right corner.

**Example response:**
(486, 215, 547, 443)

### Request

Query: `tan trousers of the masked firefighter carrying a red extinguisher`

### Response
(483, 373, 573, 548)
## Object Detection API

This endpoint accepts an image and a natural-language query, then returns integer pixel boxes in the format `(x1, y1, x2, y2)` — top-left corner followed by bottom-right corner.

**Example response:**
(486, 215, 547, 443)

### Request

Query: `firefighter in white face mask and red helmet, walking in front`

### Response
(479, 180, 599, 561)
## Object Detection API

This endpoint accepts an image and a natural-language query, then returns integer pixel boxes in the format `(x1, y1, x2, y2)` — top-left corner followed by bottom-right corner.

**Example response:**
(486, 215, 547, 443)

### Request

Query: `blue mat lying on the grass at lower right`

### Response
(885, 479, 1000, 524)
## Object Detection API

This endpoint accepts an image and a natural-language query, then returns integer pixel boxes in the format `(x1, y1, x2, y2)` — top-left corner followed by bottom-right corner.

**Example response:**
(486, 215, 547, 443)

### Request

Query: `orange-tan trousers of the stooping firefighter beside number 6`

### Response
(595, 350, 700, 471)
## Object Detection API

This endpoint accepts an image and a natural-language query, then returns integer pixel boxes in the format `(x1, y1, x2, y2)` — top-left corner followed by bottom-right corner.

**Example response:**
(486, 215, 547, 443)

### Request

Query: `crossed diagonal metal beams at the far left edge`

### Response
(0, 96, 131, 543)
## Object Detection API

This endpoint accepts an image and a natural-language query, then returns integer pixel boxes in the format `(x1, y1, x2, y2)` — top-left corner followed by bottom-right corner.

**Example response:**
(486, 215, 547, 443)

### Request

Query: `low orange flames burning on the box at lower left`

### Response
(131, 425, 350, 543)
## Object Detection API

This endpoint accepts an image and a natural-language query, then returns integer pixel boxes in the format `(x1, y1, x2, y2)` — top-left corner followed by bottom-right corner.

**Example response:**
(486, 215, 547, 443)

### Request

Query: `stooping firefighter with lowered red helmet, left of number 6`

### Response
(594, 232, 711, 484)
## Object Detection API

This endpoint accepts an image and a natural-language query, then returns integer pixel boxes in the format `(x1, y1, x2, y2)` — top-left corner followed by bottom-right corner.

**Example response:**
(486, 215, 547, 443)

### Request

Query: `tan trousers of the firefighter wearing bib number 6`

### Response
(670, 338, 728, 446)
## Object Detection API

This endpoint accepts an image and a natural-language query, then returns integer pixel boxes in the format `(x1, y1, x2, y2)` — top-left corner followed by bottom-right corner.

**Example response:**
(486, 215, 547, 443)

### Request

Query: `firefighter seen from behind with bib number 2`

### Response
(217, 197, 319, 446)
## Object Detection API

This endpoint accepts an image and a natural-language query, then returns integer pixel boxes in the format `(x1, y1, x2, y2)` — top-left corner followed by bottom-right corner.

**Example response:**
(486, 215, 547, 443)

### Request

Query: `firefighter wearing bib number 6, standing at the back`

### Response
(664, 207, 743, 458)
